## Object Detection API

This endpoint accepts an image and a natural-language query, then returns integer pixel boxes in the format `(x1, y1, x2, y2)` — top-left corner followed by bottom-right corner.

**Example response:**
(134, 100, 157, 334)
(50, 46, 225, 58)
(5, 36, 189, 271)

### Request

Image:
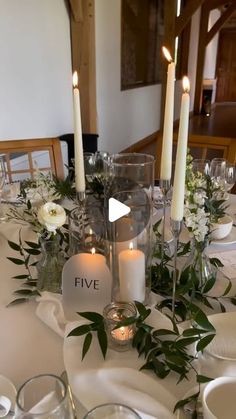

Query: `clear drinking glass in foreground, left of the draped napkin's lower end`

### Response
(14, 374, 74, 419)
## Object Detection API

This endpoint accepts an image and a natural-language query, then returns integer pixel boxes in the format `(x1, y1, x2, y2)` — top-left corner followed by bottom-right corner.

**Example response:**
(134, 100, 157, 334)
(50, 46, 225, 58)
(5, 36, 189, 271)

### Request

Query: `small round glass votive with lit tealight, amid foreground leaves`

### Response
(103, 302, 137, 352)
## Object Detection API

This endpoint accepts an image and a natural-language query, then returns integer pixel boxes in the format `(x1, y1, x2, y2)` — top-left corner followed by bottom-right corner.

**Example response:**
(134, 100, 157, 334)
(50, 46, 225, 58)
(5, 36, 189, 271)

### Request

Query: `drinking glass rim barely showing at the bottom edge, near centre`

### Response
(83, 403, 140, 419)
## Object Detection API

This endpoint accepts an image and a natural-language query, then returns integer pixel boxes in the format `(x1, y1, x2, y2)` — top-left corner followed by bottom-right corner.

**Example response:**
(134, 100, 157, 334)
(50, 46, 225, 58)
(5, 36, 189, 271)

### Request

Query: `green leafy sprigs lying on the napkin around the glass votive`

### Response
(67, 301, 215, 416)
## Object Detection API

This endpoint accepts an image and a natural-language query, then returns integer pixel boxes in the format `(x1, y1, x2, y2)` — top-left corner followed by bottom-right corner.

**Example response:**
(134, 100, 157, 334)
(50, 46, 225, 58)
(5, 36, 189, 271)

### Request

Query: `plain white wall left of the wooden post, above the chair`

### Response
(0, 0, 73, 140)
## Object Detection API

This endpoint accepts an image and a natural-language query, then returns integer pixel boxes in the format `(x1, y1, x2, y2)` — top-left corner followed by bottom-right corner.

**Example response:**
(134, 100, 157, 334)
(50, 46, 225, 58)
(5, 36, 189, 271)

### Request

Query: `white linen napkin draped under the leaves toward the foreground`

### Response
(36, 292, 177, 419)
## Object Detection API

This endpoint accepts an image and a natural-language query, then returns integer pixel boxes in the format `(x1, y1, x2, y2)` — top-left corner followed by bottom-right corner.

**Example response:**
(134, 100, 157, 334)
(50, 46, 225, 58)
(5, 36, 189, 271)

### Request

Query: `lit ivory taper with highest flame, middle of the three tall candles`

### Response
(160, 47, 175, 180)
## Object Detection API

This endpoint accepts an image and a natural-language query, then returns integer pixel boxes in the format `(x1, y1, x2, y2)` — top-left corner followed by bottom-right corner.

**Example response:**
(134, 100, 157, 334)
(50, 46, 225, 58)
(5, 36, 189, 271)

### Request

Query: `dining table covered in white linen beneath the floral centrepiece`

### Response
(0, 195, 236, 419)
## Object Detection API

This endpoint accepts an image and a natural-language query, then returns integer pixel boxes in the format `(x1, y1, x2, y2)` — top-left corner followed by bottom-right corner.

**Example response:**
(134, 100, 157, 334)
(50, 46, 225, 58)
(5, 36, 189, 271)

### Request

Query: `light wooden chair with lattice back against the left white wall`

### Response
(0, 138, 64, 182)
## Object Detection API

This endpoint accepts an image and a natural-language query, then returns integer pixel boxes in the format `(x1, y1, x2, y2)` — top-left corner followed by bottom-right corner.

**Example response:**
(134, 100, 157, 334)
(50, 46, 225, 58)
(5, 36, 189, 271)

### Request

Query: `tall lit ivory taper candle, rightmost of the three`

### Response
(171, 77, 190, 221)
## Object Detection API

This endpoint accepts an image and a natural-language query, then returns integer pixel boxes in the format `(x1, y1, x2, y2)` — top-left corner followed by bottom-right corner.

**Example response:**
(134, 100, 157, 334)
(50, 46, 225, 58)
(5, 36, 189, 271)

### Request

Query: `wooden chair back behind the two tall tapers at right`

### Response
(155, 133, 236, 179)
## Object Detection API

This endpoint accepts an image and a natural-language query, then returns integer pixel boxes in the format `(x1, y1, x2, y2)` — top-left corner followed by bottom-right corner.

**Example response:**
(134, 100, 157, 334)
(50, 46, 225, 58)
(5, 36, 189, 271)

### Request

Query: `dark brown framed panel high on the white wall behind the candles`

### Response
(121, 0, 164, 90)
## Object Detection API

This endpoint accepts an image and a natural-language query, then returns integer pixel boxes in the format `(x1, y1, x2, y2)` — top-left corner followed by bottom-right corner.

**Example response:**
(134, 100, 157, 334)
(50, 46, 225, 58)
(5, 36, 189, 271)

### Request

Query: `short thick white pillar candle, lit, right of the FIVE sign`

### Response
(118, 243, 145, 303)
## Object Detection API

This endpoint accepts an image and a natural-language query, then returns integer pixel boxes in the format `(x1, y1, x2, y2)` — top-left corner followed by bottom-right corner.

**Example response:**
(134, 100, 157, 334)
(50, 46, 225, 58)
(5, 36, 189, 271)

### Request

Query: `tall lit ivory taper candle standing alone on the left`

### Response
(73, 71, 85, 192)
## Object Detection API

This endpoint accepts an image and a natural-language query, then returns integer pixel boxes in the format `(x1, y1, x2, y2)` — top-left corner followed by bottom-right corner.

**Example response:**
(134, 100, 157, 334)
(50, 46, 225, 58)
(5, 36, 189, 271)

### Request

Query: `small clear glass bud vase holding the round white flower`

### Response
(37, 235, 65, 293)
